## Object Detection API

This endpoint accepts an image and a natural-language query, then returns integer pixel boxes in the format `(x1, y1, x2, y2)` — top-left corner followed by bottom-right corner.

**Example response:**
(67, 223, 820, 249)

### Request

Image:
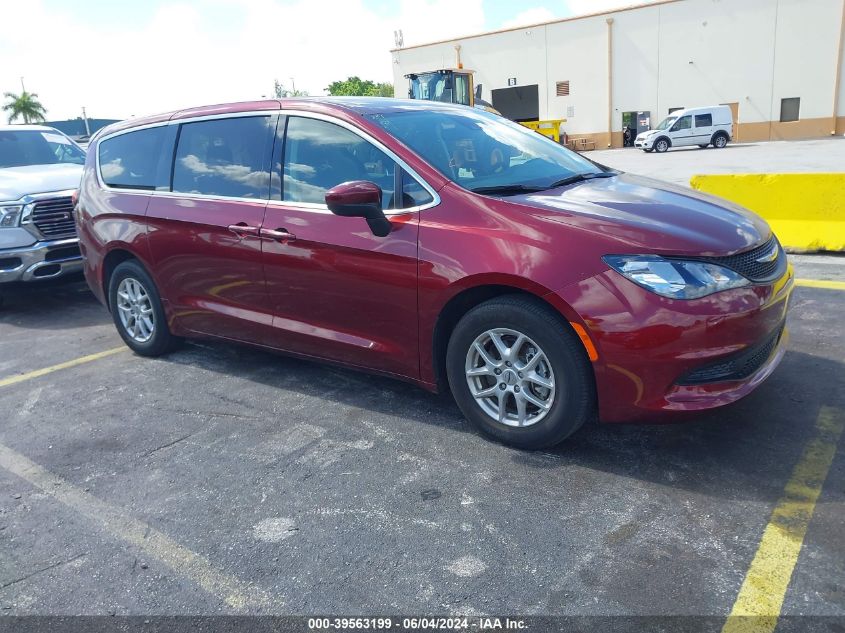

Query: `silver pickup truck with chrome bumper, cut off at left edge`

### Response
(0, 125, 85, 299)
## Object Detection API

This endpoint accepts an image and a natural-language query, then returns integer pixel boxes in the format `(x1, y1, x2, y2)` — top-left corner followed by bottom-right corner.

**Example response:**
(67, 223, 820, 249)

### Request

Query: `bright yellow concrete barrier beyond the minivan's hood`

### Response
(690, 173, 845, 252)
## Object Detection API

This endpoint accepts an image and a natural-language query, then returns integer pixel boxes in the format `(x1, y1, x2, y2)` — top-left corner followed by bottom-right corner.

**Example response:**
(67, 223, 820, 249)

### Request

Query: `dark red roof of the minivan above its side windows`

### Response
(97, 97, 467, 136)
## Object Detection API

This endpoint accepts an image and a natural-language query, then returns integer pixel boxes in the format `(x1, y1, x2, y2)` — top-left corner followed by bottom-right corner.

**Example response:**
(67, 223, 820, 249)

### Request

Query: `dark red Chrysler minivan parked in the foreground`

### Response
(77, 98, 793, 448)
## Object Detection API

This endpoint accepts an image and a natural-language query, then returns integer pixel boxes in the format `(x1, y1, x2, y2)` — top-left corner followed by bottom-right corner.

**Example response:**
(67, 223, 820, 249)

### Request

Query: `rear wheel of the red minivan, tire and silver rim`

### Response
(109, 260, 178, 356)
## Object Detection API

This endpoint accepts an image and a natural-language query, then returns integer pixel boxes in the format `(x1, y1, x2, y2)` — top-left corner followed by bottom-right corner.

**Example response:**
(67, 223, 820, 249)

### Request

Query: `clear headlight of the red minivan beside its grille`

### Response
(602, 255, 751, 299)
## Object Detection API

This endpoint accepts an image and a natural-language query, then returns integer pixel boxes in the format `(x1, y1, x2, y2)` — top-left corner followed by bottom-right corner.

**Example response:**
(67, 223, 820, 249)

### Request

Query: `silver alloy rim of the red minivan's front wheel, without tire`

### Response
(466, 328, 555, 427)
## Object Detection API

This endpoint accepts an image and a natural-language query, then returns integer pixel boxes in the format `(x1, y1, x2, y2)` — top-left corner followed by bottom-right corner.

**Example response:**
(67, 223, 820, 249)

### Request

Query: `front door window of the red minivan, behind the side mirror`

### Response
(282, 117, 397, 209)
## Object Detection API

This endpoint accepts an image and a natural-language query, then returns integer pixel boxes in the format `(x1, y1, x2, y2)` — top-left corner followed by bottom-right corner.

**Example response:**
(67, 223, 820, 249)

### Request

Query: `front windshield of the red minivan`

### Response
(368, 108, 609, 193)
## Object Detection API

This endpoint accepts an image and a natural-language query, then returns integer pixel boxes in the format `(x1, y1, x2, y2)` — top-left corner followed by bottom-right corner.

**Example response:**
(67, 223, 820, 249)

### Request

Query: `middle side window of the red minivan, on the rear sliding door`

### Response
(173, 116, 272, 199)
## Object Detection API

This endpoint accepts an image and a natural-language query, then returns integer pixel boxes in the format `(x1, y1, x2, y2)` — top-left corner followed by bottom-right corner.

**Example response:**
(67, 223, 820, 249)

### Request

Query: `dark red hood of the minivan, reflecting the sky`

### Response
(506, 174, 771, 256)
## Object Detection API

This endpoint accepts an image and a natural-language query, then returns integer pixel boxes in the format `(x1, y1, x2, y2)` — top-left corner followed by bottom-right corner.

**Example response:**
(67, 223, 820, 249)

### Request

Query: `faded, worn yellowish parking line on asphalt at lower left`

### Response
(0, 444, 272, 611)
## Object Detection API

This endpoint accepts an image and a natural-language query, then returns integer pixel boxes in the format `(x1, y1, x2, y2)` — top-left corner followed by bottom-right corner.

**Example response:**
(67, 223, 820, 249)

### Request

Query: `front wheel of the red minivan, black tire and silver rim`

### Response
(446, 295, 595, 450)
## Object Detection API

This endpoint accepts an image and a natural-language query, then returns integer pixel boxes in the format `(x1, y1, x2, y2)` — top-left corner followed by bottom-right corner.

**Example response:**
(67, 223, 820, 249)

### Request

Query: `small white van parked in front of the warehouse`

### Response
(634, 106, 733, 153)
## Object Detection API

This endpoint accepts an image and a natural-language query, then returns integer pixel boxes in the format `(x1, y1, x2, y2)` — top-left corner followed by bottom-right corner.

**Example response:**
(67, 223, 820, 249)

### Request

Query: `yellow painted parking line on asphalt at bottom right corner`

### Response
(722, 407, 845, 633)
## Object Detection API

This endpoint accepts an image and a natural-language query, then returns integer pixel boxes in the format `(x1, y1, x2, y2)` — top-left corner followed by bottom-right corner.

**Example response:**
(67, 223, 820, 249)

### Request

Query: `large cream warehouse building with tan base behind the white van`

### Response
(391, 0, 845, 148)
